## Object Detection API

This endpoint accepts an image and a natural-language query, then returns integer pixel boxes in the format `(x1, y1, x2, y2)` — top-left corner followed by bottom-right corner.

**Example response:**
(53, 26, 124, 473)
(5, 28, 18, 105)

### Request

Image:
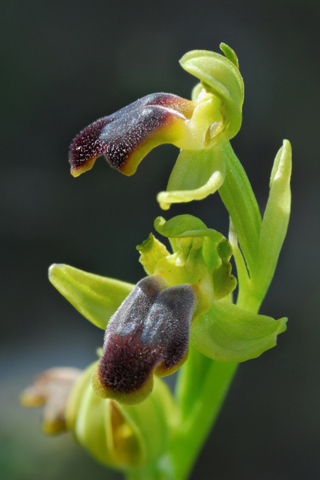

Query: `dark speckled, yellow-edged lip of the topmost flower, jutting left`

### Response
(69, 93, 194, 176)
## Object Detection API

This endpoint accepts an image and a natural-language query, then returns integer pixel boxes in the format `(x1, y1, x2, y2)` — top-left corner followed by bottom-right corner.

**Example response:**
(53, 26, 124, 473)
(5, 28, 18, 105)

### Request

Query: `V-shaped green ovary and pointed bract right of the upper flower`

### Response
(225, 140, 292, 312)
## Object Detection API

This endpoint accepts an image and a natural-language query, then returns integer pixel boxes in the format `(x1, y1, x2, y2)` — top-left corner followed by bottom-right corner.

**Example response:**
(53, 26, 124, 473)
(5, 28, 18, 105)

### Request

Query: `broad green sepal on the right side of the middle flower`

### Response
(191, 301, 287, 363)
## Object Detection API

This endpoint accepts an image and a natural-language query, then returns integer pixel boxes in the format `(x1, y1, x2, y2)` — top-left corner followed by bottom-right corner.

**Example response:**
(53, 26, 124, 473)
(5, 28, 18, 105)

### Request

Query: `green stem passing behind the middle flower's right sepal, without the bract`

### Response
(128, 142, 272, 480)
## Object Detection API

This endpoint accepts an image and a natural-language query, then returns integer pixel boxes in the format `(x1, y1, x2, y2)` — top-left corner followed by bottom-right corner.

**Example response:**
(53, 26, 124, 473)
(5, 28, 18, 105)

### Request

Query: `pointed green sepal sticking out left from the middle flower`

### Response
(49, 264, 134, 330)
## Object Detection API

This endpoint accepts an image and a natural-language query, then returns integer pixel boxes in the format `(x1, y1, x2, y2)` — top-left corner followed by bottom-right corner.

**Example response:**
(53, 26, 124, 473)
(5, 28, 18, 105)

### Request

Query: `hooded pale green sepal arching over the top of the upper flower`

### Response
(180, 44, 244, 144)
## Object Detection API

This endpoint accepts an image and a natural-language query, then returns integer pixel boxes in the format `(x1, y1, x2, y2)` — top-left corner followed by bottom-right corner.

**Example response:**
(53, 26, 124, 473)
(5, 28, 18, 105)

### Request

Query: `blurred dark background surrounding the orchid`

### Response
(0, 0, 320, 480)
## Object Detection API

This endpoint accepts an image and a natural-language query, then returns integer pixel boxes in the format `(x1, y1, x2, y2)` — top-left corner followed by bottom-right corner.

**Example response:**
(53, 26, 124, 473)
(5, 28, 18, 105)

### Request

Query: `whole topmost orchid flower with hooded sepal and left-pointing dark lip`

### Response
(69, 44, 244, 209)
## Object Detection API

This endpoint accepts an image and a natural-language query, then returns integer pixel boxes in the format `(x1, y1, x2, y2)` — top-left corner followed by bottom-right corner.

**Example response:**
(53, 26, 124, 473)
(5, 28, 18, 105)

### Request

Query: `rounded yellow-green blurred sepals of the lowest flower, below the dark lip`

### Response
(66, 362, 179, 471)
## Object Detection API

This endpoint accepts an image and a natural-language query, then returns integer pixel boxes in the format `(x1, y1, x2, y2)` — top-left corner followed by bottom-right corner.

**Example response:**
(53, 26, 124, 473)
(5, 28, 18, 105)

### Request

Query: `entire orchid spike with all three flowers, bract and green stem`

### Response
(22, 44, 291, 480)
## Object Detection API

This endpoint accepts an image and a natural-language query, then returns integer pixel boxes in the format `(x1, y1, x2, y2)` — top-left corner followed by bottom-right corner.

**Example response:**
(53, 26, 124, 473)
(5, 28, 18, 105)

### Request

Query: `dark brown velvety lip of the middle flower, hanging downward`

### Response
(94, 275, 196, 403)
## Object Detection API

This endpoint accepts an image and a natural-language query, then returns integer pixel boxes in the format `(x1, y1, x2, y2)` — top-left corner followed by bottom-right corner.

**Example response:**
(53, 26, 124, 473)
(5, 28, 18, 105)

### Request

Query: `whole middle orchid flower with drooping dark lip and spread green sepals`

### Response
(49, 215, 286, 405)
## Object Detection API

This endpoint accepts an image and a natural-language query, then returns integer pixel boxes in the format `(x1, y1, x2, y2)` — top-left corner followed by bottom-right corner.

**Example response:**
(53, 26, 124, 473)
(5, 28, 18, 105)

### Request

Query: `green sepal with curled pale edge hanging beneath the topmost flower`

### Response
(157, 147, 225, 210)
